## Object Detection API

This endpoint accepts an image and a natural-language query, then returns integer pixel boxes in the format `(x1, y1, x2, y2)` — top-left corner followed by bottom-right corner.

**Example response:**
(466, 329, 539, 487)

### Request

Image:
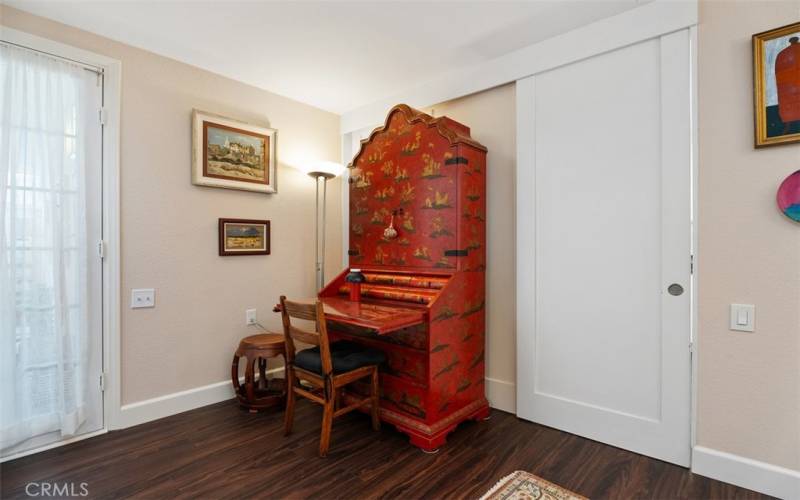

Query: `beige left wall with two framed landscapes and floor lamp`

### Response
(0, 6, 342, 404)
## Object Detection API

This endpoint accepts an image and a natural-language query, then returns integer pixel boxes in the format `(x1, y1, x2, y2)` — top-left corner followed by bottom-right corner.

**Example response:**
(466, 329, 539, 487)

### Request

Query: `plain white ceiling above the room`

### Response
(5, 0, 644, 114)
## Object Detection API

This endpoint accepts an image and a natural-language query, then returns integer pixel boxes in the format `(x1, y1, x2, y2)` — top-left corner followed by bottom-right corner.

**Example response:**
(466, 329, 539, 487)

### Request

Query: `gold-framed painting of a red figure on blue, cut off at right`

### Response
(753, 23, 800, 148)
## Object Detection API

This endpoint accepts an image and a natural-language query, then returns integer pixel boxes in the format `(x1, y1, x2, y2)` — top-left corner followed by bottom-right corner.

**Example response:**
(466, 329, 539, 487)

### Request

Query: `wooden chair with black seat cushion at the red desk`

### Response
(281, 296, 386, 457)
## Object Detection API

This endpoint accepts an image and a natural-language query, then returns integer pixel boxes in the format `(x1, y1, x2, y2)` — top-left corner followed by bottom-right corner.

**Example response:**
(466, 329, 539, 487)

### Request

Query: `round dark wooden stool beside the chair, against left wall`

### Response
(231, 333, 286, 413)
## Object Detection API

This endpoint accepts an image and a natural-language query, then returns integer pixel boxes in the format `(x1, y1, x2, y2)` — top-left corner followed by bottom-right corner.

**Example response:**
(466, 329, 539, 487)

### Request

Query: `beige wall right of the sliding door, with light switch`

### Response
(697, 1, 800, 470)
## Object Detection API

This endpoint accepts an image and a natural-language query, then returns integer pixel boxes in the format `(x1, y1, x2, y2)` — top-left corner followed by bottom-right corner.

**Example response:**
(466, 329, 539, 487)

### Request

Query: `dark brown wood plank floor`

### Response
(0, 401, 767, 499)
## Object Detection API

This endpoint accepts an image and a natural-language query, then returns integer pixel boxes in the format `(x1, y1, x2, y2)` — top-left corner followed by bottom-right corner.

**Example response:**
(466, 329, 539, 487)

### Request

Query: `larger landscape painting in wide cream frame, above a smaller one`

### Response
(192, 110, 277, 193)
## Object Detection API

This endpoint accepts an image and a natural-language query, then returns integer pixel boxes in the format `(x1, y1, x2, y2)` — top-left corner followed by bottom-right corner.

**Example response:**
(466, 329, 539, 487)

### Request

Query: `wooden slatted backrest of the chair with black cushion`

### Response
(281, 295, 333, 376)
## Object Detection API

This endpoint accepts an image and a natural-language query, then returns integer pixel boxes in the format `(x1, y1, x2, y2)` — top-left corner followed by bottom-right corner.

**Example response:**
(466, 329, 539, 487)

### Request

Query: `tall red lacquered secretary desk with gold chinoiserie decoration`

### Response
(319, 105, 489, 450)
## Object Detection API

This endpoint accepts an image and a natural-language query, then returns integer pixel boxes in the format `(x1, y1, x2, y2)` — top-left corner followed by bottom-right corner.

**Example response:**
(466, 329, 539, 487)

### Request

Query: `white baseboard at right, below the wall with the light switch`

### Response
(692, 446, 800, 500)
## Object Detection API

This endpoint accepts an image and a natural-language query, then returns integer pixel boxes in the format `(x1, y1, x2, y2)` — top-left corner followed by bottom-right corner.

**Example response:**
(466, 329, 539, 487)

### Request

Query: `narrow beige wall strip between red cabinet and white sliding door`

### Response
(425, 83, 517, 411)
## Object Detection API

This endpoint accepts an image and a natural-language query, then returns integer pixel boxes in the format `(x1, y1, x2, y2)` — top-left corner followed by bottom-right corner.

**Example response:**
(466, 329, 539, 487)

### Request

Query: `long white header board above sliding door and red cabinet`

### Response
(341, 0, 698, 134)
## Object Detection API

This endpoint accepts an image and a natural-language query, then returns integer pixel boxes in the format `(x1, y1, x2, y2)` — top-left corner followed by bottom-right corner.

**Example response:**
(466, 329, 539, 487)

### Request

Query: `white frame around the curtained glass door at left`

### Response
(0, 24, 122, 462)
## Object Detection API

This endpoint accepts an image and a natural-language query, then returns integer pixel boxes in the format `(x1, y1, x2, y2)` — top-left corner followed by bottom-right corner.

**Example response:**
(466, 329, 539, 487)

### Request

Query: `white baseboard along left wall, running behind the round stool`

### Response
(114, 366, 283, 429)
